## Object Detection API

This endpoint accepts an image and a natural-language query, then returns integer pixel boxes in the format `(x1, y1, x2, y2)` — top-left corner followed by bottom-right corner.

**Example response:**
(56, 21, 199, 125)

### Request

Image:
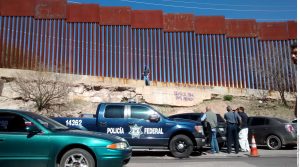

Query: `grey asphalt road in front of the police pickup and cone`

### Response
(126, 148, 297, 167)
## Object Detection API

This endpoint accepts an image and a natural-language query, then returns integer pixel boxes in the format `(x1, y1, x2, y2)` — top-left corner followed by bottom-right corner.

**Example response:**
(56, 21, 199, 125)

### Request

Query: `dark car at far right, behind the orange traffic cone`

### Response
(248, 116, 297, 150)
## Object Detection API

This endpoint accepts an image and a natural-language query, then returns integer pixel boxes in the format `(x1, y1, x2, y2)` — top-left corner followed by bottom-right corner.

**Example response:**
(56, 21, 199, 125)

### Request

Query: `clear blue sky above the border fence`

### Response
(68, 0, 297, 22)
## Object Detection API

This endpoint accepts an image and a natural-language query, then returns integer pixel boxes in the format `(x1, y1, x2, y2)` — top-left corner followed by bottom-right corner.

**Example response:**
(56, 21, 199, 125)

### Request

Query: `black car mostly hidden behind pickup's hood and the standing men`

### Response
(169, 113, 226, 148)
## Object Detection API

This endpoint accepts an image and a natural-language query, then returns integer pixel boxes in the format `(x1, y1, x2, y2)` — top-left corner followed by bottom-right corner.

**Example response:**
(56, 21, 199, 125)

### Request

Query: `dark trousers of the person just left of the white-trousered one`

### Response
(227, 123, 239, 153)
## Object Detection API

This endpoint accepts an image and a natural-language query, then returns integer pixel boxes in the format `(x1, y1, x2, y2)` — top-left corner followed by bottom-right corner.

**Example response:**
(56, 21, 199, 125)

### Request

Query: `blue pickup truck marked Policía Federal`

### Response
(53, 103, 205, 158)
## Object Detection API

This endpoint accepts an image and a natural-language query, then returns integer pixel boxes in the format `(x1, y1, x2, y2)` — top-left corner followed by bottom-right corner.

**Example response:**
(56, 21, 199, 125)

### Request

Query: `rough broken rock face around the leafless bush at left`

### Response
(0, 77, 144, 116)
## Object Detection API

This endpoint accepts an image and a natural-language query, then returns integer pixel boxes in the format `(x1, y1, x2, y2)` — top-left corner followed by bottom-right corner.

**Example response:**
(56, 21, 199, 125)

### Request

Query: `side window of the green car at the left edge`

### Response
(0, 113, 28, 132)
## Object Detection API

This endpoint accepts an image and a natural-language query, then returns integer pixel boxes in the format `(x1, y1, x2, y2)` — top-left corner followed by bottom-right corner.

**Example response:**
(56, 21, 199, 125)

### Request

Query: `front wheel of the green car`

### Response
(59, 148, 95, 167)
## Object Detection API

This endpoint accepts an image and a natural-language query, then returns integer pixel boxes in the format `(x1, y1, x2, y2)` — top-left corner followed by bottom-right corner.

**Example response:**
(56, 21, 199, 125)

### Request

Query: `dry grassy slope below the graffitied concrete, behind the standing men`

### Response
(154, 97, 295, 121)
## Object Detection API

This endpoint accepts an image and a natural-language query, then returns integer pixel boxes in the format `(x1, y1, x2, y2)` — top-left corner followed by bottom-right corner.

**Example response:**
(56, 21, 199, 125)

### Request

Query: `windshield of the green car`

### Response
(27, 113, 69, 131)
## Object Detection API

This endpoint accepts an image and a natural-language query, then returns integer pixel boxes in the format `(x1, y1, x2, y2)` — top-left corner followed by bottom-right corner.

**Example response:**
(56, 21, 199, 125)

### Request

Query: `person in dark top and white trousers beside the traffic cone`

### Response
(238, 107, 250, 152)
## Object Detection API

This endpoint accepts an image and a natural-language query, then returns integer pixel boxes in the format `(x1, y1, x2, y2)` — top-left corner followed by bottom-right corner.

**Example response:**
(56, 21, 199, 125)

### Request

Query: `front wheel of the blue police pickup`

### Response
(169, 135, 193, 158)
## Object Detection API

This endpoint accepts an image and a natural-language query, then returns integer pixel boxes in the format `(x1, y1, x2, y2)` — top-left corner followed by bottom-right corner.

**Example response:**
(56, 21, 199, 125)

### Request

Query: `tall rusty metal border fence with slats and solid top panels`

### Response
(0, 0, 297, 91)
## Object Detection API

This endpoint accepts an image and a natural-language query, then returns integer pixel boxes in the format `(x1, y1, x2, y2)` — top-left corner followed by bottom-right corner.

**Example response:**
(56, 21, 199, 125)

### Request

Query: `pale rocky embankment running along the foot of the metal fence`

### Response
(0, 69, 295, 120)
